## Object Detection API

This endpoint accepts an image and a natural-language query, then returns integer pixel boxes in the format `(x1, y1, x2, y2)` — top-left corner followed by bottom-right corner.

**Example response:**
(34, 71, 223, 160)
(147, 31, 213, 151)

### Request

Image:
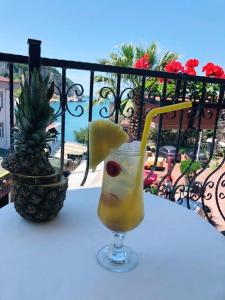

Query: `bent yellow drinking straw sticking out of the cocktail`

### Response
(140, 101, 192, 156)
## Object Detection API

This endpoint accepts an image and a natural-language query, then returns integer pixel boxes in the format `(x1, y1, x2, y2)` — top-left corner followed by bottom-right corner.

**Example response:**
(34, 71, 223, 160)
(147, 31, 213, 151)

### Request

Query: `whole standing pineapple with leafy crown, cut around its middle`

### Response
(2, 70, 68, 222)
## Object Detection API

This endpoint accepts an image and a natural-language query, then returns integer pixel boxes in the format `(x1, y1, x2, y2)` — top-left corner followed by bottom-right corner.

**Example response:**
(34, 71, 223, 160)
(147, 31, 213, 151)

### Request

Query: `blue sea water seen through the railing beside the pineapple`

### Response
(51, 98, 109, 142)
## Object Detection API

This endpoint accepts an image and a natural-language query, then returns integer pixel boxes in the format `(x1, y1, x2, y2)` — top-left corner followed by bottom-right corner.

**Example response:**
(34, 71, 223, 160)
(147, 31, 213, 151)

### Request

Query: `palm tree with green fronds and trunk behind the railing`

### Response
(95, 42, 178, 139)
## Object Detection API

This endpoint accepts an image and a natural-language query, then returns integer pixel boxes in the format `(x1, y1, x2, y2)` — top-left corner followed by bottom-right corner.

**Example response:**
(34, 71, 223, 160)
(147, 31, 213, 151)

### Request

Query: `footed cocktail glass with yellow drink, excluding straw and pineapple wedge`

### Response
(97, 142, 144, 272)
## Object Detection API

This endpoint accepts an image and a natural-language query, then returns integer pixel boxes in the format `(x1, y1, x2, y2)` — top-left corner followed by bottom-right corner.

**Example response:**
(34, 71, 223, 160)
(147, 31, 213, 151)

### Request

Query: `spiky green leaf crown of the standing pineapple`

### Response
(14, 69, 55, 155)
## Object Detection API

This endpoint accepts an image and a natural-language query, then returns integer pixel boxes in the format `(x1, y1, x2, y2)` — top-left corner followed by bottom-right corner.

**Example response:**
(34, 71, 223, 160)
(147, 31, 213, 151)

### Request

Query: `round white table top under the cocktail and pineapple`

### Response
(0, 188, 225, 300)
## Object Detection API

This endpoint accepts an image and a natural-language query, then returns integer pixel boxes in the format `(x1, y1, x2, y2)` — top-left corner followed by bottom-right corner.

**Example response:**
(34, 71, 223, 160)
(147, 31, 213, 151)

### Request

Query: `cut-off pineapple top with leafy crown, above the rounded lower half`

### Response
(2, 70, 55, 176)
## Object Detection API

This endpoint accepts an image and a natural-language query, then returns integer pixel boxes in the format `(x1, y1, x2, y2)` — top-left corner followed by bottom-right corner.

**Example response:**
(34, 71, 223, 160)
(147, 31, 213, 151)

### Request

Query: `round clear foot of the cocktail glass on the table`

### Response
(97, 245, 138, 273)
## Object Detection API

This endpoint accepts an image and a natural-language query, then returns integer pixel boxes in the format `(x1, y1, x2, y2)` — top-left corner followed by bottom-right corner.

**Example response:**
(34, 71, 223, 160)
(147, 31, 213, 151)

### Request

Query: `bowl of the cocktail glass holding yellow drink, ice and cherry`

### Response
(98, 142, 144, 232)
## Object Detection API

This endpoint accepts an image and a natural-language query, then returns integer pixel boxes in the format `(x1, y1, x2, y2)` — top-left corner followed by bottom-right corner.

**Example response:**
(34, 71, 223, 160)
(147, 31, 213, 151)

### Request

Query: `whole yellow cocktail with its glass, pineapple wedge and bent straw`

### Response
(90, 102, 191, 272)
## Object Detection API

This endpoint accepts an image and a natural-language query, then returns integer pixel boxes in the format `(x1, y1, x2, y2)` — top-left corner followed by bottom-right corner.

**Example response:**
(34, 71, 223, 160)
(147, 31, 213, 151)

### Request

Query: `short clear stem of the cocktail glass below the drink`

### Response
(110, 232, 127, 264)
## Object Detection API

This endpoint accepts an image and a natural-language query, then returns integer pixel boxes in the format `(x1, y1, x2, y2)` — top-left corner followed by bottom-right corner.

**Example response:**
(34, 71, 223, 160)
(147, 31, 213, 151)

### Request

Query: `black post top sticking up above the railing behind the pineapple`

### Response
(27, 39, 41, 82)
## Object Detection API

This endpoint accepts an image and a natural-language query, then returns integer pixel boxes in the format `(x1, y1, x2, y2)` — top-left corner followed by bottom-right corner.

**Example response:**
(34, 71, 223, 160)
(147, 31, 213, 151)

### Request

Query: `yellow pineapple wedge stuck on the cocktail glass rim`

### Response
(89, 120, 129, 171)
